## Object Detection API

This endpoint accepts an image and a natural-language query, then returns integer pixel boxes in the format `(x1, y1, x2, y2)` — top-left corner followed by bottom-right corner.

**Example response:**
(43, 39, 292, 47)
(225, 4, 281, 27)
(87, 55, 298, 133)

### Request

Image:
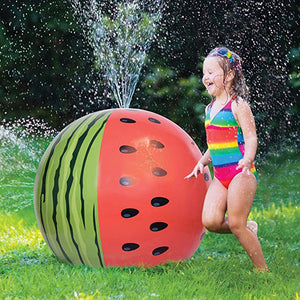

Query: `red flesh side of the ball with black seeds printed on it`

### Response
(98, 109, 210, 266)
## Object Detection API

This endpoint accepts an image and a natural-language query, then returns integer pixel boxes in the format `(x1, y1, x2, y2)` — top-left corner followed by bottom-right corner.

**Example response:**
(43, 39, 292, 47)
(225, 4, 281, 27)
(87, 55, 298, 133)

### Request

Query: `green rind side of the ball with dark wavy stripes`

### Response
(35, 111, 111, 267)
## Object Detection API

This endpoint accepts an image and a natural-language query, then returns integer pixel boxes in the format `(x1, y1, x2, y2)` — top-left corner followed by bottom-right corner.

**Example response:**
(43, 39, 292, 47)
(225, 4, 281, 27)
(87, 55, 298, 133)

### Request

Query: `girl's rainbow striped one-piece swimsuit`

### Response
(205, 97, 257, 188)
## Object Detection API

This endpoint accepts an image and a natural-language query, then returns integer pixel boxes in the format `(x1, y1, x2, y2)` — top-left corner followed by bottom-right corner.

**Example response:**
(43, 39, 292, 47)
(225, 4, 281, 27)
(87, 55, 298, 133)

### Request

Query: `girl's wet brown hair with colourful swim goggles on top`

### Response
(207, 47, 249, 100)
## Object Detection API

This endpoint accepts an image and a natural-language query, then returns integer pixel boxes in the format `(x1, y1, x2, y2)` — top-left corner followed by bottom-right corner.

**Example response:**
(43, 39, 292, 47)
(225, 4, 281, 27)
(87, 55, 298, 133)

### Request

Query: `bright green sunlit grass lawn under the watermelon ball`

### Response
(0, 132, 300, 300)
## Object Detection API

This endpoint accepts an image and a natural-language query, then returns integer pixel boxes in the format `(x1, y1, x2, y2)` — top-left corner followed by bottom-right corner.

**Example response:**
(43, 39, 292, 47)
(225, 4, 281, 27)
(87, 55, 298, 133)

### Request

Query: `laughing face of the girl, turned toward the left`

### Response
(202, 56, 226, 97)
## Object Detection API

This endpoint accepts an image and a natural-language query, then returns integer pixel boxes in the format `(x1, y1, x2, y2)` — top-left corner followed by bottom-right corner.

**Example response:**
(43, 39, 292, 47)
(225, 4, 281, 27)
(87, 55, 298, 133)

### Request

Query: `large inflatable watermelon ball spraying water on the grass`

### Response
(34, 109, 210, 267)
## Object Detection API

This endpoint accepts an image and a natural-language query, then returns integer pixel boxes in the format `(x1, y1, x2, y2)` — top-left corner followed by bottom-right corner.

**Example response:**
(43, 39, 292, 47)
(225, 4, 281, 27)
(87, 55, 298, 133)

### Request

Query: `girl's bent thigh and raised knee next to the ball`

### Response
(202, 178, 230, 233)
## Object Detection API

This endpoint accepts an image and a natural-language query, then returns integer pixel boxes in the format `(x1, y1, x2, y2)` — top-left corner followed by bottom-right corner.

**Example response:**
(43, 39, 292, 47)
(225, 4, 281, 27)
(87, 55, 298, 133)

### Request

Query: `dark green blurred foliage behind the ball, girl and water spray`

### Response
(0, 0, 300, 150)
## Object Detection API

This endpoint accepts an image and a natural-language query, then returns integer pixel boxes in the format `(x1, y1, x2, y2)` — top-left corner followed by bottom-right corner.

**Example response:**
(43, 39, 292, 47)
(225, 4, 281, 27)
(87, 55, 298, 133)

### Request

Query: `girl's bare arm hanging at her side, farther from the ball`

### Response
(233, 101, 257, 172)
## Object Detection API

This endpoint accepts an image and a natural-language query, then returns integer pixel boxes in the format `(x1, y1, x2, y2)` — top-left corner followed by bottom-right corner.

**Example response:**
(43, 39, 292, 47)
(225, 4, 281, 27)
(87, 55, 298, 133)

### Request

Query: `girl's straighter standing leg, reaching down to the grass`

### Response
(227, 173, 268, 271)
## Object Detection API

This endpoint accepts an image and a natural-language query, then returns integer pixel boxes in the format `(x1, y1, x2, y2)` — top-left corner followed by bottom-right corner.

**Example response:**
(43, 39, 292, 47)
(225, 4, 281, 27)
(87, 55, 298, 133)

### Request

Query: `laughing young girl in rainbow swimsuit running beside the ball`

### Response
(186, 47, 268, 272)
